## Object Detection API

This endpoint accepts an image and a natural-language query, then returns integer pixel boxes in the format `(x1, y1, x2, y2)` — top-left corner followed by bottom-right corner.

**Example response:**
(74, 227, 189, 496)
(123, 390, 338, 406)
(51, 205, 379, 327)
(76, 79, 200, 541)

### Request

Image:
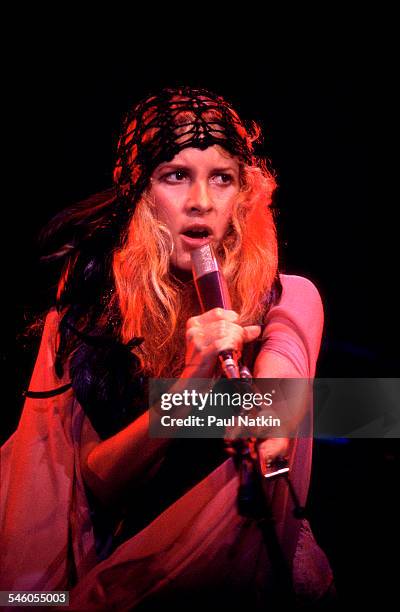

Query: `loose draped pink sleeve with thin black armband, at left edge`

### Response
(0, 310, 96, 591)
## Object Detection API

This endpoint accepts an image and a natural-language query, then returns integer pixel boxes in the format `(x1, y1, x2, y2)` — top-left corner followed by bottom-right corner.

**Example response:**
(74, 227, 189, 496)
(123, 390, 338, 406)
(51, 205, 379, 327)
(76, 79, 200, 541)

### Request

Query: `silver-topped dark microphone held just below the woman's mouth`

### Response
(190, 244, 240, 378)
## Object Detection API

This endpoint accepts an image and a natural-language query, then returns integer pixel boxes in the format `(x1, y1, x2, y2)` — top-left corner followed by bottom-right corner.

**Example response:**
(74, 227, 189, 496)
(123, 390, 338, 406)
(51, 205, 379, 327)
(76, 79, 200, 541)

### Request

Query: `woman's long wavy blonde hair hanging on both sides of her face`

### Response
(113, 163, 278, 377)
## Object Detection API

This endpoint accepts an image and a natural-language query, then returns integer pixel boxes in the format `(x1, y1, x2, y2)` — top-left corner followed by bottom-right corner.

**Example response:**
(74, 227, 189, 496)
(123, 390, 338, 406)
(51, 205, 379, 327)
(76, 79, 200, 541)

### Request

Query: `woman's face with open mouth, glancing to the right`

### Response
(150, 146, 240, 270)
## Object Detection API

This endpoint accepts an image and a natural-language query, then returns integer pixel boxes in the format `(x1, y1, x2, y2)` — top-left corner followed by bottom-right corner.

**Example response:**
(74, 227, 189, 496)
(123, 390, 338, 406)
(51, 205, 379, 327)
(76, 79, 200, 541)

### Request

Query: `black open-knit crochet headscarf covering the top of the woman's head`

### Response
(114, 87, 259, 206)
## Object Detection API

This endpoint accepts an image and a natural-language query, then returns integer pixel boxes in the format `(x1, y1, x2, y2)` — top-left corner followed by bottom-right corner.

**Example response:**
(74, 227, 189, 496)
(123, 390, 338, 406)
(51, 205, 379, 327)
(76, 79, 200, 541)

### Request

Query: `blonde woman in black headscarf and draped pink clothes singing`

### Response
(1, 87, 333, 610)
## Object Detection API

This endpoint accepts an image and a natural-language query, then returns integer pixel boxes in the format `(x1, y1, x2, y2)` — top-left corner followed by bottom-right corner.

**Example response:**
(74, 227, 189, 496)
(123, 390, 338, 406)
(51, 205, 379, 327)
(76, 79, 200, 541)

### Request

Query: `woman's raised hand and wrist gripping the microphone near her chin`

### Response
(183, 308, 261, 378)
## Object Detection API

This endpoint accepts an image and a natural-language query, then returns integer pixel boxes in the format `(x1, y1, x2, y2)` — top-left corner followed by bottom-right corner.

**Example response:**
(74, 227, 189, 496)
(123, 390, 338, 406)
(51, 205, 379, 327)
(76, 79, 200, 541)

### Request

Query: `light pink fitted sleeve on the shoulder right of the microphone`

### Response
(261, 274, 324, 378)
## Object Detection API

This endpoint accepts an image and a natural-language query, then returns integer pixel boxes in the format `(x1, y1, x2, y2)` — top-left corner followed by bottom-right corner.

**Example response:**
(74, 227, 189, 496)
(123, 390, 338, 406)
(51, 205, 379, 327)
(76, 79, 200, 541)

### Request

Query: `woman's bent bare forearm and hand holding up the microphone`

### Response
(80, 308, 260, 503)
